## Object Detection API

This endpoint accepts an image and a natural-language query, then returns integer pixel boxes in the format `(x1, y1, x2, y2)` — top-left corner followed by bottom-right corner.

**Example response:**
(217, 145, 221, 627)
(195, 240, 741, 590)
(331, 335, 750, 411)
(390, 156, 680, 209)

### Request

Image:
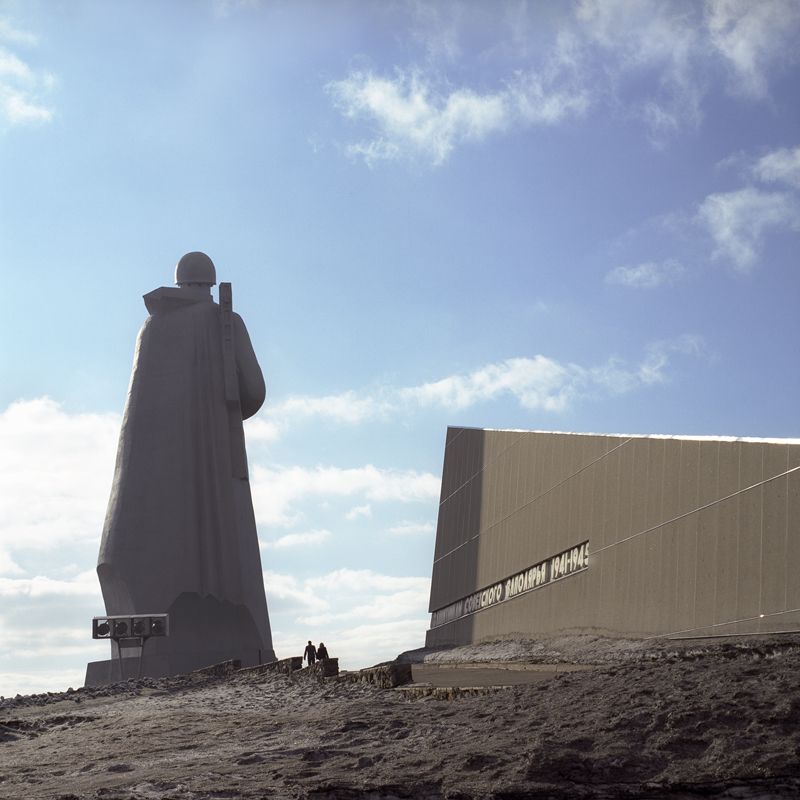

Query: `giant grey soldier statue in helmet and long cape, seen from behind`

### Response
(87, 253, 275, 685)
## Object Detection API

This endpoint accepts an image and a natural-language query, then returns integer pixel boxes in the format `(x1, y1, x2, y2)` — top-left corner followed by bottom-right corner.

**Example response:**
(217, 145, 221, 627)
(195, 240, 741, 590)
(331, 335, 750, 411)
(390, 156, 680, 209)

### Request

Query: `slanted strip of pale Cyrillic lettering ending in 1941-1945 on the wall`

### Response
(431, 541, 589, 628)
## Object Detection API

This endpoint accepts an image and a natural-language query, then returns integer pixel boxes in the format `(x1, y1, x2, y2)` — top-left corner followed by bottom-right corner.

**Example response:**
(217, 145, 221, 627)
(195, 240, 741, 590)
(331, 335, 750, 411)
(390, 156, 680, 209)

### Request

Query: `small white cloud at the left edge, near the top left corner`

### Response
(0, 18, 55, 125)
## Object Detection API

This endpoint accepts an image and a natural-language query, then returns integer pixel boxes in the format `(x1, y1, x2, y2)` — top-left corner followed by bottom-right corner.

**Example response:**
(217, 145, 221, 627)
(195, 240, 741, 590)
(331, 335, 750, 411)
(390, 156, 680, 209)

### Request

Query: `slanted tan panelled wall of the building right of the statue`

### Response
(427, 428, 800, 645)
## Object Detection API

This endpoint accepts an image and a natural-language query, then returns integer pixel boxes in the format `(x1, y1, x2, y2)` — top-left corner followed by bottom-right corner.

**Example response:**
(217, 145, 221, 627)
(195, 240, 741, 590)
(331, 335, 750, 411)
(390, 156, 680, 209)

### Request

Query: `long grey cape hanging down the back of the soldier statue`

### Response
(98, 288, 269, 642)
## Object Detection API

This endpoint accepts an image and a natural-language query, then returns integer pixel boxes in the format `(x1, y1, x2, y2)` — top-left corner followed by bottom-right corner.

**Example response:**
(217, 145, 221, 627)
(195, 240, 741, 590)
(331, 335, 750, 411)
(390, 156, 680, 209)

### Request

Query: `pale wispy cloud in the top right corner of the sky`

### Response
(706, 0, 800, 98)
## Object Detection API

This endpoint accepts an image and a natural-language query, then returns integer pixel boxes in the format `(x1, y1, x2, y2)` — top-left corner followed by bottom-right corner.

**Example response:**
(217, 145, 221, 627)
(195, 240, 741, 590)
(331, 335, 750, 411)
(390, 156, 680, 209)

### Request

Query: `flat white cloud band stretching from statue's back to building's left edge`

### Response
(251, 464, 440, 527)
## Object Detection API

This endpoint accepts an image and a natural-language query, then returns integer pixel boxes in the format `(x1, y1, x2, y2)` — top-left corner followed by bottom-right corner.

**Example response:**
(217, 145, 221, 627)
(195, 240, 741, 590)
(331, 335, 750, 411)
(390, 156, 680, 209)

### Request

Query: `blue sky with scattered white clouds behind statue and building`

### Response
(0, 0, 800, 694)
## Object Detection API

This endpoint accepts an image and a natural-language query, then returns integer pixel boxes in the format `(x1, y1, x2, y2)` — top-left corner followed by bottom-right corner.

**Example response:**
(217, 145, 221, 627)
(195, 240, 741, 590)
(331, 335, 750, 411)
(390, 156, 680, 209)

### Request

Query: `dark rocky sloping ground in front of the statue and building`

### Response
(0, 636, 800, 800)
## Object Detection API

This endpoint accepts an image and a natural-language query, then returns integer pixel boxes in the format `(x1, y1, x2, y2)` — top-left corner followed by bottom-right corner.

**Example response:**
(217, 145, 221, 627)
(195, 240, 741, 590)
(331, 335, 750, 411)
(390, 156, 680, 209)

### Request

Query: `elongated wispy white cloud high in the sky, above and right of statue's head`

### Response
(326, 70, 586, 165)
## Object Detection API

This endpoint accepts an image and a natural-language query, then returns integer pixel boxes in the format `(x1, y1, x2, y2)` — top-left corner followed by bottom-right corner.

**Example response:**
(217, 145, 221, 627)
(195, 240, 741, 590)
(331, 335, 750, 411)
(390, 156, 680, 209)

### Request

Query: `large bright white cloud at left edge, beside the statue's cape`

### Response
(0, 397, 120, 554)
